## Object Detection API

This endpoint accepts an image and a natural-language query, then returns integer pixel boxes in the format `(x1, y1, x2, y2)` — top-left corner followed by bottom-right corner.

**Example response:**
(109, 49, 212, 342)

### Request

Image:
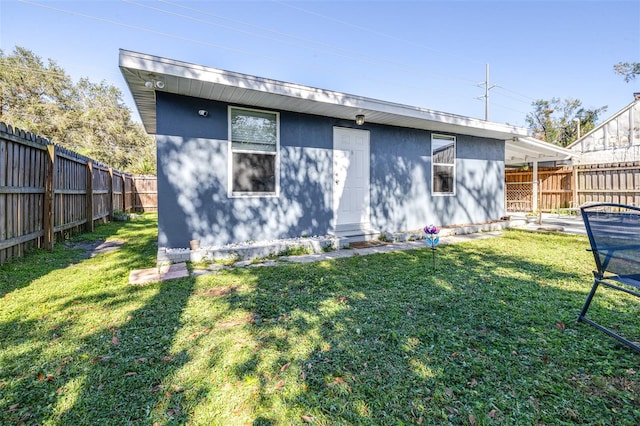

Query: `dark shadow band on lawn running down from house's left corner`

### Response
(54, 278, 194, 424)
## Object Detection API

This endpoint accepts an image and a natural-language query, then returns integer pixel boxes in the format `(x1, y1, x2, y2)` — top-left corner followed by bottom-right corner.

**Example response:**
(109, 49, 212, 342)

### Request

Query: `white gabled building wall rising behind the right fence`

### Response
(568, 101, 640, 164)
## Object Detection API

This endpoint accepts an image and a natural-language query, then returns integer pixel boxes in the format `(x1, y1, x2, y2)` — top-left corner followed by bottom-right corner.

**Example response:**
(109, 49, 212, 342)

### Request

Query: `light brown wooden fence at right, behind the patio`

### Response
(505, 162, 640, 212)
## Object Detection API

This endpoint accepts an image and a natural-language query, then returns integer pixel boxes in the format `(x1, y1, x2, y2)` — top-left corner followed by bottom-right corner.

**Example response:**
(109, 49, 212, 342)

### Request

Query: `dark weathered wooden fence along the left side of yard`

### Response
(0, 122, 157, 264)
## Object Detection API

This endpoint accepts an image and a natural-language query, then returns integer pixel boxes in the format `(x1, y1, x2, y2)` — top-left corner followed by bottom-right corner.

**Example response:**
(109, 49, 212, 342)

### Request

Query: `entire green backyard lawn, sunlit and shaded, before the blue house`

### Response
(0, 215, 640, 425)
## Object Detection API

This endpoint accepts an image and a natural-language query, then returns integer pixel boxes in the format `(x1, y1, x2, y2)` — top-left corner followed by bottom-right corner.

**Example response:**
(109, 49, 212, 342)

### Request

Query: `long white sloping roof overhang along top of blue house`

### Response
(120, 49, 528, 141)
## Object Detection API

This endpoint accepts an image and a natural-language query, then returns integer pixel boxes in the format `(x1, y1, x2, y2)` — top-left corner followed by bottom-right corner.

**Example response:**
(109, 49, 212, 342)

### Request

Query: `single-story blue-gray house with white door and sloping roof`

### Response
(120, 50, 544, 248)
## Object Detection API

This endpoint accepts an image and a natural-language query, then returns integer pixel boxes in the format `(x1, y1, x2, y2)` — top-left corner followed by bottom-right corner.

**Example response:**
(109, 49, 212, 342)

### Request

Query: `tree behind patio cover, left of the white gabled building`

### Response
(526, 98, 607, 147)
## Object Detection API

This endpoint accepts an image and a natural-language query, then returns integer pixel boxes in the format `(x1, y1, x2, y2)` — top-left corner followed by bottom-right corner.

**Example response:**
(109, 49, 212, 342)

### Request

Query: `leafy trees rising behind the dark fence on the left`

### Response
(0, 47, 156, 173)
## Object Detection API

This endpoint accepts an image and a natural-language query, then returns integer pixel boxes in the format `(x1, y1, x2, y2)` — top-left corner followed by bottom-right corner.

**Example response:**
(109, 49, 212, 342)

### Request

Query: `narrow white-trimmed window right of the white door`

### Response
(431, 135, 456, 195)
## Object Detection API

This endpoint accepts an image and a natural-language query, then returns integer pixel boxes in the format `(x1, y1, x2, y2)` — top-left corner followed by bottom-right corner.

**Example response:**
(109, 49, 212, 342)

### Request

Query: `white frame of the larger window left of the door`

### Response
(227, 106, 280, 198)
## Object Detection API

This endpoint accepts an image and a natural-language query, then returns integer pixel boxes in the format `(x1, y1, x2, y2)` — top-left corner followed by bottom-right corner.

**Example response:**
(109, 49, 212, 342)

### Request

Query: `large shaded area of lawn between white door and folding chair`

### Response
(206, 233, 640, 424)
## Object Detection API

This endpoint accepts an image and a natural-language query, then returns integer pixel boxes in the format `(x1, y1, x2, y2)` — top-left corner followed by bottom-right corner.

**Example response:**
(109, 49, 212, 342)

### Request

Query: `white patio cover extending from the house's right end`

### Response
(505, 137, 576, 165)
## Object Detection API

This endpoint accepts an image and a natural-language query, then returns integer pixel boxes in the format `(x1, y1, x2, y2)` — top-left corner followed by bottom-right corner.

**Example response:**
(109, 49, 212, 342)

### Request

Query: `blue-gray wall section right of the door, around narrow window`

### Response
(371, 126, 504, 231)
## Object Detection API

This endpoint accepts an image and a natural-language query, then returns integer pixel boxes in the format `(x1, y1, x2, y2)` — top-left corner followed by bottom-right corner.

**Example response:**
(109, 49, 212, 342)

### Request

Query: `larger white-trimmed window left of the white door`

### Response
(229, 107, 279, 195)
